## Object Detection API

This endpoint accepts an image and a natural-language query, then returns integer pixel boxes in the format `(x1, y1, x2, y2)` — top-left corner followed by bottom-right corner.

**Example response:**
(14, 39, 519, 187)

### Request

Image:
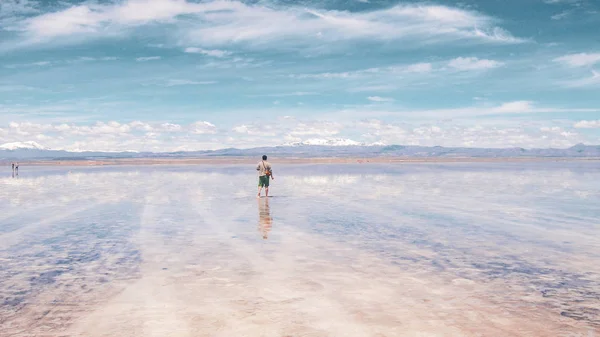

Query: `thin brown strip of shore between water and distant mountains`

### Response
(0, 157, 600, 166)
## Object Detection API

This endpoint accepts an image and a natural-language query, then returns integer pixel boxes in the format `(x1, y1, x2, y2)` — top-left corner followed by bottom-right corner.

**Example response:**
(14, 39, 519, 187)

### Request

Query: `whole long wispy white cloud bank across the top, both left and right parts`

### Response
(9, 0, 523, 47)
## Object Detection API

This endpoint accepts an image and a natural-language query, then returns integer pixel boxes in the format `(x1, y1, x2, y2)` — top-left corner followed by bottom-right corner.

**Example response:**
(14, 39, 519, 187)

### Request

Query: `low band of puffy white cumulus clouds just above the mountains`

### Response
(0, 117, 600, 151)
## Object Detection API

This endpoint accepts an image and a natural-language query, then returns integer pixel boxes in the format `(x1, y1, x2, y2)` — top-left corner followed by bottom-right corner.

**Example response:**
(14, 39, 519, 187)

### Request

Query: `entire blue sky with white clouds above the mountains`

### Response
(0, 0, 600, 152)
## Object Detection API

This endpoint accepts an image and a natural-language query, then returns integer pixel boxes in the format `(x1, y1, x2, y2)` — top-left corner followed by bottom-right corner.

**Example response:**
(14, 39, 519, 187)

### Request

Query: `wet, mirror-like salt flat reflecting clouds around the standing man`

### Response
(0, 162, 600, 337)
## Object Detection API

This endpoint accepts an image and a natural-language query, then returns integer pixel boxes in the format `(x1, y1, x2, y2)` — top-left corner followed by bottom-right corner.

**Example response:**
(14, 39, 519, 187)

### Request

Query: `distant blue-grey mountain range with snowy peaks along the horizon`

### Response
(0, 142, 600, 160)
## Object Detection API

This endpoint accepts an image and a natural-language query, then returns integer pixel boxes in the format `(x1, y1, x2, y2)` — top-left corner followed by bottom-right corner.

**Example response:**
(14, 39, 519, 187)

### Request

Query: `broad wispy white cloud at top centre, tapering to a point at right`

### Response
(188, 2, 521, 45)
